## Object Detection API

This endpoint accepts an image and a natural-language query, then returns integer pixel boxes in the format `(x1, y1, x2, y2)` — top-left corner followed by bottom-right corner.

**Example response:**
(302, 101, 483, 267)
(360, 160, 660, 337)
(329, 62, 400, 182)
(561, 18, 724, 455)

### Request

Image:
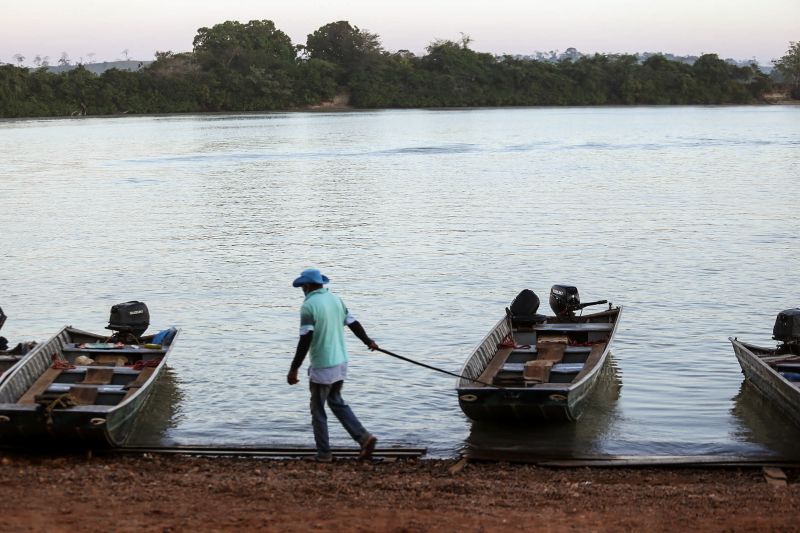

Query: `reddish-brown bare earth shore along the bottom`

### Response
(0, 454, 800, 532)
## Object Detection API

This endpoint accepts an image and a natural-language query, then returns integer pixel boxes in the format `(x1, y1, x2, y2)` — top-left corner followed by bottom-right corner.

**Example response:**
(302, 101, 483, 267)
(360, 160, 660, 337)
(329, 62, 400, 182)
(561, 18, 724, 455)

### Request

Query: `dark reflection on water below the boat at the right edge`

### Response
(731, 380, 800, 460)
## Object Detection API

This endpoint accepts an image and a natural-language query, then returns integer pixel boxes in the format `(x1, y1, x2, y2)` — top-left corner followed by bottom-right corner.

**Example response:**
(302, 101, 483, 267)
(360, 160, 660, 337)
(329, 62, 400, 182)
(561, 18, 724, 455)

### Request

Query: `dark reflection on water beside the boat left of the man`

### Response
(126, 367, 183, 446)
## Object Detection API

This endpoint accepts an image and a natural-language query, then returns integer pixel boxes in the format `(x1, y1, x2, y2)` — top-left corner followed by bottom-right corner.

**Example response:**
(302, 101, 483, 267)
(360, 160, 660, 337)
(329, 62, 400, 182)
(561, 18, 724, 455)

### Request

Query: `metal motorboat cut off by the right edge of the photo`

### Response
(728, 308, 800, 425)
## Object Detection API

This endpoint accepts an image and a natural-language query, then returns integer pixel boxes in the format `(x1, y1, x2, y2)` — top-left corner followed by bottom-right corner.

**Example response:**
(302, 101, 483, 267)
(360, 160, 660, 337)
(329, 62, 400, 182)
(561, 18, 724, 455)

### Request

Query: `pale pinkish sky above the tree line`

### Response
(0, 0, 800, 65)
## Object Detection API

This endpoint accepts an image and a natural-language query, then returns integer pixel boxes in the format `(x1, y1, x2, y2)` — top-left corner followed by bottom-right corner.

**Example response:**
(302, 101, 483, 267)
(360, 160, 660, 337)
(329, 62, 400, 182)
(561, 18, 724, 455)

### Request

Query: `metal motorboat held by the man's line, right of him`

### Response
(456, 285, 622, 421)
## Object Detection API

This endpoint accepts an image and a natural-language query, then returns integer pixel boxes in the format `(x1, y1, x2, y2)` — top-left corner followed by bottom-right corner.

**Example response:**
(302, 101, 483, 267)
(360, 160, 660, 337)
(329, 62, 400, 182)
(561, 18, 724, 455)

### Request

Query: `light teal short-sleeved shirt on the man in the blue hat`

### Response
(300, 288, 348, 368)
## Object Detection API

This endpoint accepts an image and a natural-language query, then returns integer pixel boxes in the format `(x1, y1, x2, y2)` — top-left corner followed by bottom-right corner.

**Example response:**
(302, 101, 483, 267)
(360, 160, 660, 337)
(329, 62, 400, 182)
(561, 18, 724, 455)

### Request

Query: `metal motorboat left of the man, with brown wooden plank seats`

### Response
(0, 302, 179, 449)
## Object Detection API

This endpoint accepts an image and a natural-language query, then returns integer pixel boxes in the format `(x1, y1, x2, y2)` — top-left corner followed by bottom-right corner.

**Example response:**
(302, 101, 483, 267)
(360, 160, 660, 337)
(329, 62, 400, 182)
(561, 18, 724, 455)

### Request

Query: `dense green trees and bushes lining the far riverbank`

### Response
(0, 20, 788, 117)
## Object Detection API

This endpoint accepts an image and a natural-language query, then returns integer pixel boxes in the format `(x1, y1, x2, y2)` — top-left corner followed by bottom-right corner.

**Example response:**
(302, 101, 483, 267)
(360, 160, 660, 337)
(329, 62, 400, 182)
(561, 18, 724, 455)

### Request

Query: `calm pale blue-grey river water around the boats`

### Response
(0, 106, 800, 457)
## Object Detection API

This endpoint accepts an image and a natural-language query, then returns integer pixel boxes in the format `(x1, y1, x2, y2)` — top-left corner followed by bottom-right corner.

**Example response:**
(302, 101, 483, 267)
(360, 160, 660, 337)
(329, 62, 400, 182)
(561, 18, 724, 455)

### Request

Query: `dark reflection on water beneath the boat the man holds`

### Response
(462, 356, 622, 461)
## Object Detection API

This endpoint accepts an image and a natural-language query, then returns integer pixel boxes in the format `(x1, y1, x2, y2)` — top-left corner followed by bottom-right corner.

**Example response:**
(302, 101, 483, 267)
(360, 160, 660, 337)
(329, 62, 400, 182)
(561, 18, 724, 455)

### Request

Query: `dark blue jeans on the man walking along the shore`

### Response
(310, 381, 369, 458)
